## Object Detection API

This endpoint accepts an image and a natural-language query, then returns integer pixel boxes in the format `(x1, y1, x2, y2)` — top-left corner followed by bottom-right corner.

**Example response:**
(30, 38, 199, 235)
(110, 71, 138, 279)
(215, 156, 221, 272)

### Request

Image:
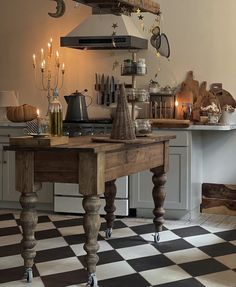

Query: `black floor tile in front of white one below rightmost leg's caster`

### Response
(127, 254, 175, 272)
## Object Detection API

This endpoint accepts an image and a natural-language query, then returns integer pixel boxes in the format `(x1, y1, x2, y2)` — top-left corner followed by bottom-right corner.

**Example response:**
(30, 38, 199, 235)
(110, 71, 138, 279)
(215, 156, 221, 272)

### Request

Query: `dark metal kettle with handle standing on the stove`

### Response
(64, 90, 92, 122)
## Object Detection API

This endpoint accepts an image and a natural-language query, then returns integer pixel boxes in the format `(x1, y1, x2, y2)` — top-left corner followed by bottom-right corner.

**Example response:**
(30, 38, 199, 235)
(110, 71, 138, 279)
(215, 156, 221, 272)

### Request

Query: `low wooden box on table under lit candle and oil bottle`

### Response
(10, 136, 69, 147)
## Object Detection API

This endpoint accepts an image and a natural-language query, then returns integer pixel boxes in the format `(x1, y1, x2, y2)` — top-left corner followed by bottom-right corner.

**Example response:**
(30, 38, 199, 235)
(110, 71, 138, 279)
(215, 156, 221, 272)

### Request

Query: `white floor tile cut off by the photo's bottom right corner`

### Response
(196, 270, 236, 287)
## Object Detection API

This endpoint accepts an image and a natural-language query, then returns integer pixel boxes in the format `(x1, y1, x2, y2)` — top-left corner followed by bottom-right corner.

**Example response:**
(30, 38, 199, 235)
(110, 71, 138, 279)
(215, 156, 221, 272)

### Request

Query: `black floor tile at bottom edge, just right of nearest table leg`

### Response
(99, 273, 150, 287)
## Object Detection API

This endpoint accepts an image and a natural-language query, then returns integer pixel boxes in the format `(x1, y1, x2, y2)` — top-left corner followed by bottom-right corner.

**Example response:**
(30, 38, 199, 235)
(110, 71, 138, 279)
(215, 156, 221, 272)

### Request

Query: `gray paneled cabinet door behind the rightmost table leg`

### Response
(130, 147, 188, 209)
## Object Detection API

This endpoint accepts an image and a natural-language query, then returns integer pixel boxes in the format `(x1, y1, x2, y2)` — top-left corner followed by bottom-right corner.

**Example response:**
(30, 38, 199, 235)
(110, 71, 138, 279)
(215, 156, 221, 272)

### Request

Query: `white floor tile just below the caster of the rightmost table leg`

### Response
(116, 244, 160, 260)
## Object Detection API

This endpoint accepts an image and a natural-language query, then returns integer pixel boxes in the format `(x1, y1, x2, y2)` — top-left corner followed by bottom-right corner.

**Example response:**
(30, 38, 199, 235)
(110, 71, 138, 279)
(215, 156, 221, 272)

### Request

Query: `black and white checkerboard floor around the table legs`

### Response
(0, 213, 236, 287)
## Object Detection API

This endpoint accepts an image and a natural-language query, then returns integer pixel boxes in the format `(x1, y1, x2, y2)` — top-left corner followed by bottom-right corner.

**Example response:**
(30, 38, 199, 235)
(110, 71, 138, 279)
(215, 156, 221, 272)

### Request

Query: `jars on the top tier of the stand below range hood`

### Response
(122, 58, 147, 75)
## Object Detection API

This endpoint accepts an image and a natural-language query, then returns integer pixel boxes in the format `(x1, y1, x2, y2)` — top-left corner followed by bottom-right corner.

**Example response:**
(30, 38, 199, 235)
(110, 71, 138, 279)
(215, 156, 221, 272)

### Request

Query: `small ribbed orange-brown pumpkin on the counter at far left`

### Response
(7, 104, 37, 122)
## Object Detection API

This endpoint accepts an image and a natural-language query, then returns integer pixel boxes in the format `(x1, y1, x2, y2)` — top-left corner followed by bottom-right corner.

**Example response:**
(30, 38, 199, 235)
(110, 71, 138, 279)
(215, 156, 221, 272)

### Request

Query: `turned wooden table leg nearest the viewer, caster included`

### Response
(83, 196, 101, 287)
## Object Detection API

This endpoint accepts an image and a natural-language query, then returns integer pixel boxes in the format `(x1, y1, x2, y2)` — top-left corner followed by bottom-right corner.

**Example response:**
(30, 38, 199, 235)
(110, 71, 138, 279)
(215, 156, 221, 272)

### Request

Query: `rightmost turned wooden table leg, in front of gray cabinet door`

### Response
(151, 167, 167, 242)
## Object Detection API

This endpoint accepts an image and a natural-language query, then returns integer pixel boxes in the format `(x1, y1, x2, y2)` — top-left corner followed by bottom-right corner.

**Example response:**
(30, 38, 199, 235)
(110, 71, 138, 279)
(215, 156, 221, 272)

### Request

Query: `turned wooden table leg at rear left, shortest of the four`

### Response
(104, 180, 116, 238)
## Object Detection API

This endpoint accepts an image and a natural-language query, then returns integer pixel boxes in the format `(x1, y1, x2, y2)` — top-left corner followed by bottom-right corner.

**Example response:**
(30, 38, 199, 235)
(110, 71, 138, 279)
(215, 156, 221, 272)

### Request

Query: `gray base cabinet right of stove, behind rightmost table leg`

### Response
(130, 130, 202, 218)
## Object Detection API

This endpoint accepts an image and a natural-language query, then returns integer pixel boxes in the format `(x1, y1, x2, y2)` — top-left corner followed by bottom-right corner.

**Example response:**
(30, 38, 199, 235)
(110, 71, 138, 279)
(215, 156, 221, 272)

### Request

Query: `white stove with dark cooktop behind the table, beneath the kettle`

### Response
(54, 119, 129, 216)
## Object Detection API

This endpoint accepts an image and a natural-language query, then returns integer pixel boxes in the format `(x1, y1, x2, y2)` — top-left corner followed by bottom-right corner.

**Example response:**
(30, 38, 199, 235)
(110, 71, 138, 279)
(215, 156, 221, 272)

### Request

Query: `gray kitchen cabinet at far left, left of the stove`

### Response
(0, 123, 53, 210)
